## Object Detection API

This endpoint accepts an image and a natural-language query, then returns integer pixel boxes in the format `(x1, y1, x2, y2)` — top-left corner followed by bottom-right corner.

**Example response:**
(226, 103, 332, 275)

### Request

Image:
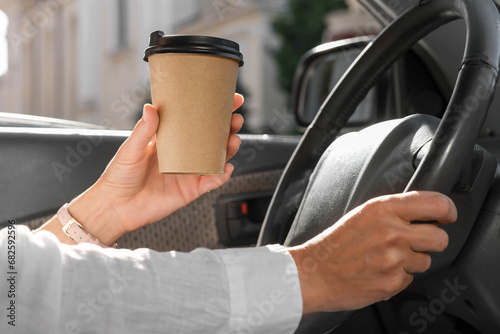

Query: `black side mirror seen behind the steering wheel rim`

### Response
(292, 36, 373, 127)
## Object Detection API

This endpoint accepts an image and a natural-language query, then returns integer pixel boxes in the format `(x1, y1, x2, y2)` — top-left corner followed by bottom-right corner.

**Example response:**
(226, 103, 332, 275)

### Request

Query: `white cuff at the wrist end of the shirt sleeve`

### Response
(215, 245, 302, 334)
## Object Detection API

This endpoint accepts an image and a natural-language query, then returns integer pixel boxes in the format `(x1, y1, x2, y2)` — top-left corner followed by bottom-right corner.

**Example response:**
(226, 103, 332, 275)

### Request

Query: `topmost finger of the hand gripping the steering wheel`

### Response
(386, 191, 457, 224)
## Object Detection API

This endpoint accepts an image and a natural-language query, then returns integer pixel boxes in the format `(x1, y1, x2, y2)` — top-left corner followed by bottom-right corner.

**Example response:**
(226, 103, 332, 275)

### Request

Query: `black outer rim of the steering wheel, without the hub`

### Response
(257, 0, 500, 246)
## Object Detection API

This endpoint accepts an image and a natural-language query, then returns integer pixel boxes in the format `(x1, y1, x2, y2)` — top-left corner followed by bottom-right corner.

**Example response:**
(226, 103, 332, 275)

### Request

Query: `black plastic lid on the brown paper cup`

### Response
(144, 30, 243, 67)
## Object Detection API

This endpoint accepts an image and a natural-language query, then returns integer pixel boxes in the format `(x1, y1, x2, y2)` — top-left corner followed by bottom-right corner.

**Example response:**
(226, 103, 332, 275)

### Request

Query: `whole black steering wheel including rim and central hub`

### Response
(258, 0, 500, 333)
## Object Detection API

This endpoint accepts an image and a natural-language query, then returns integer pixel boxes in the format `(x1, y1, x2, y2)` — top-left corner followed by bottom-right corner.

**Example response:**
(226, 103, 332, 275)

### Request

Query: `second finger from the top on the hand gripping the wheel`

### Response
(409, 224, 448, 252)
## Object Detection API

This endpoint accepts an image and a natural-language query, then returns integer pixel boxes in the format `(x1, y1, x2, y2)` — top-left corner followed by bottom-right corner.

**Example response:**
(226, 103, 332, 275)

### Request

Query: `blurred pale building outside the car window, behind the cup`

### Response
(0, 0, 286, 131)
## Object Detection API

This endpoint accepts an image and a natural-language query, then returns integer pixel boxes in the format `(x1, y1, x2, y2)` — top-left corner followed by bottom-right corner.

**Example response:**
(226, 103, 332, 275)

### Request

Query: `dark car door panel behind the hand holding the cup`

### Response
(0, 128, 299, 251)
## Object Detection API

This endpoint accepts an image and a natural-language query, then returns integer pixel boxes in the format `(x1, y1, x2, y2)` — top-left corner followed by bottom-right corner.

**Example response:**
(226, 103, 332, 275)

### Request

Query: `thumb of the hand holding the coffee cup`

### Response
(121, 104, 159, 154)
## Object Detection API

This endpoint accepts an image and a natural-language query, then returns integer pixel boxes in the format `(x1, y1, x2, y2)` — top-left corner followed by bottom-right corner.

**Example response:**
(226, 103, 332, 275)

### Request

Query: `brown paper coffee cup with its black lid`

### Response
(144, 31, 243, 175)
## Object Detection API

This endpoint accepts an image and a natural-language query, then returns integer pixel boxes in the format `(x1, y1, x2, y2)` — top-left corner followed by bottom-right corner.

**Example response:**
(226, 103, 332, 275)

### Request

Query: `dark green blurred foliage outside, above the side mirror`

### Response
(272, 0, 347, 94)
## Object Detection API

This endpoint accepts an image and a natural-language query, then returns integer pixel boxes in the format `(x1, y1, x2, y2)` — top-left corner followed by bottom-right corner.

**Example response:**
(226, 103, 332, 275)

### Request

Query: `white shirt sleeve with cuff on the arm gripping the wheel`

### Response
(0, 225, 302, 334)
